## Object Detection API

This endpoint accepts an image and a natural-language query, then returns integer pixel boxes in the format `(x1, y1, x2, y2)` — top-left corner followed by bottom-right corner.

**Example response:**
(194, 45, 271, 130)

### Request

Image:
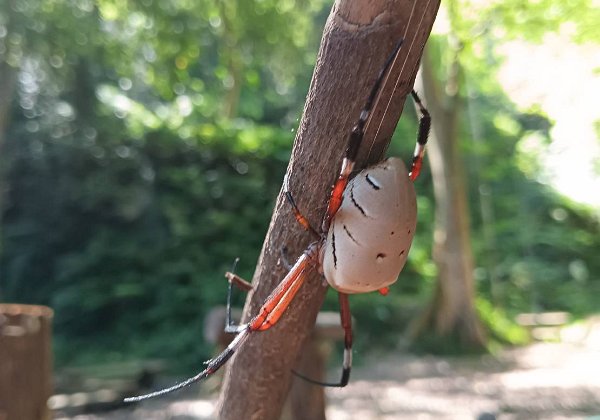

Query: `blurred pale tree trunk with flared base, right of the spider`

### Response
(413, 44, 485, 350)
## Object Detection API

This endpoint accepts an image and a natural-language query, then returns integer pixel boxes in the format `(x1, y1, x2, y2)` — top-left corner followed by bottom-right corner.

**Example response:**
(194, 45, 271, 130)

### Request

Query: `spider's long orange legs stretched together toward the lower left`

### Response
(124, 244, 317, 403)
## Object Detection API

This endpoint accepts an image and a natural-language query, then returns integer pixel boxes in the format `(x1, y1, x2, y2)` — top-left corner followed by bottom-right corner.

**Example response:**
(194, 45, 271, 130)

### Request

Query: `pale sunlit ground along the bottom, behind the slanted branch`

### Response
(56, 319, 600, 420)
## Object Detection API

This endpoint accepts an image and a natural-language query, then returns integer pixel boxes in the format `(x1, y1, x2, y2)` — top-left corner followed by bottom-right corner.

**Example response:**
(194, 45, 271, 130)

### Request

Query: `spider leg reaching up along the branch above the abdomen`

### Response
(322, 40, 403, 232)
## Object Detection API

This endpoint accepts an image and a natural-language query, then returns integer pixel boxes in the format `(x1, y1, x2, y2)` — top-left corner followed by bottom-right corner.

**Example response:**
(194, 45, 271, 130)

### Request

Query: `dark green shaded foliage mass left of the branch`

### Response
(2, 115, 289, 368)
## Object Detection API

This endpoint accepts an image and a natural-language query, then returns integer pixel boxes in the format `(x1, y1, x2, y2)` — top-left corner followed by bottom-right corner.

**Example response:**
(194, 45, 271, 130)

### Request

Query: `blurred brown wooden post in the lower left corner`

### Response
(0, 304, 53, 420)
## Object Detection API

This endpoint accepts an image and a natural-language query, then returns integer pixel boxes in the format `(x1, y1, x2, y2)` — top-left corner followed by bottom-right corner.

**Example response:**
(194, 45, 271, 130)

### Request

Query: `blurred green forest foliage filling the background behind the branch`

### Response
(0, 0, 600, 376)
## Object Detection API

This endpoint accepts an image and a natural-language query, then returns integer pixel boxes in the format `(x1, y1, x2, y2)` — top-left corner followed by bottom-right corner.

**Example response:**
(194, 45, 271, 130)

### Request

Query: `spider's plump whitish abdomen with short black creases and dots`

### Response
(323, 158, 417, 293)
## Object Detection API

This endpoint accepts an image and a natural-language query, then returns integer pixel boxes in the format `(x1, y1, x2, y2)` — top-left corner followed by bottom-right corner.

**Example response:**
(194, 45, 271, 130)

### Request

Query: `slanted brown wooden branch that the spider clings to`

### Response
(218, 0, 439, 420)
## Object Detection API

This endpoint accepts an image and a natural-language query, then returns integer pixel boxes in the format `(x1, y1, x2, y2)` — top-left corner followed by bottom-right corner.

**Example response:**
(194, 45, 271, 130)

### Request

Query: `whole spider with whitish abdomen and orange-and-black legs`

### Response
(125, 41, 431, 402)
